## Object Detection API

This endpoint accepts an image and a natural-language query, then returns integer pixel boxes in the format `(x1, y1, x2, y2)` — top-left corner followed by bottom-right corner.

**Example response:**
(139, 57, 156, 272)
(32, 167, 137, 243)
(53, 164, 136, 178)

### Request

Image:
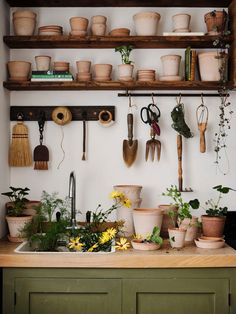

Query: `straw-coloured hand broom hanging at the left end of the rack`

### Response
(8, 113, 32, 167)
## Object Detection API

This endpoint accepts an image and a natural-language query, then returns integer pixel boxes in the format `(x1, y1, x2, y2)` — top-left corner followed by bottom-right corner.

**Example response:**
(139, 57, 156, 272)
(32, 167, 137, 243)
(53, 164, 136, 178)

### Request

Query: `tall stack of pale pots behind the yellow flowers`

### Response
(114, 185, 142, 237)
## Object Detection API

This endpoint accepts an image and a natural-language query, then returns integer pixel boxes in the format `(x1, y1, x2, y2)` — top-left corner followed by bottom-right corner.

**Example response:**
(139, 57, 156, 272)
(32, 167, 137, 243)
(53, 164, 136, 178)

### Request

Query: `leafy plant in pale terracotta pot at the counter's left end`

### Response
(2, 186, 33, 242)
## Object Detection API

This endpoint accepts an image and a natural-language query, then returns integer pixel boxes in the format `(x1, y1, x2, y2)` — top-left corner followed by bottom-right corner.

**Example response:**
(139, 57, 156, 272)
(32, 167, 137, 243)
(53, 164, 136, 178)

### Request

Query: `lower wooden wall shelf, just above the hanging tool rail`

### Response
(3, 81, 233, 91)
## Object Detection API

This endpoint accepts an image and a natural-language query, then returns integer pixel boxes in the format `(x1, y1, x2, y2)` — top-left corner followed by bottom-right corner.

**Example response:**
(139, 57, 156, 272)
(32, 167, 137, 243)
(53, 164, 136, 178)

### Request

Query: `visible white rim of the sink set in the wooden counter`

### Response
(14, 242, 115, 255)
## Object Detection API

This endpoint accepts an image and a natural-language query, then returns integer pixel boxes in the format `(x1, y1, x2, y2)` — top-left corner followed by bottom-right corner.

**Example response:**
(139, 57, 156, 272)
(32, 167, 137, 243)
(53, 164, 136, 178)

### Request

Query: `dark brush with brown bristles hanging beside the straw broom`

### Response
(34, 111, 49, 170)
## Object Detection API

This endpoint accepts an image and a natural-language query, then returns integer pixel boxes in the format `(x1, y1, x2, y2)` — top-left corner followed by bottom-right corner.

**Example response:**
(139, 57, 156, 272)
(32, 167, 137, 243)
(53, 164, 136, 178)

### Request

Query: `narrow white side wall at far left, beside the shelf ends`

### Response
(0, 1, 10, 238)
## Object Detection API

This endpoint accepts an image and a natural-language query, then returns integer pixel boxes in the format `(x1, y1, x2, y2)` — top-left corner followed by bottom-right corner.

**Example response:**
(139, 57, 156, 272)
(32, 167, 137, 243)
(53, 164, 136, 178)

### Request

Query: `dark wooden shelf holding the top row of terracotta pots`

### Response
(3, 35, 233, 49)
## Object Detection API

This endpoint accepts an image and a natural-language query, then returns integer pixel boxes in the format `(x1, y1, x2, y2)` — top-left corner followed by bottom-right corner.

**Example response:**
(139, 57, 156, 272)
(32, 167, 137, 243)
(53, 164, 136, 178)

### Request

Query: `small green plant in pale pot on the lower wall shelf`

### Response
(115, 45, 134, 81)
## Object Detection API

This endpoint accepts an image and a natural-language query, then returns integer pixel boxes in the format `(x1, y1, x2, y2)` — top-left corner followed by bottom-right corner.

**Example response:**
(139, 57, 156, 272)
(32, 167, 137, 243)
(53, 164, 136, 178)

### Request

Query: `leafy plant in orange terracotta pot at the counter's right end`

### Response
(201, 185, 235, 238)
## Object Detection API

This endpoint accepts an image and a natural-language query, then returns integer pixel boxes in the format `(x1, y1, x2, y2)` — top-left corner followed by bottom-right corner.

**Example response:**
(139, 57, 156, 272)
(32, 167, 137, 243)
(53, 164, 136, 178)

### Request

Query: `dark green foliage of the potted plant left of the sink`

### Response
(2, 186, 30, 217)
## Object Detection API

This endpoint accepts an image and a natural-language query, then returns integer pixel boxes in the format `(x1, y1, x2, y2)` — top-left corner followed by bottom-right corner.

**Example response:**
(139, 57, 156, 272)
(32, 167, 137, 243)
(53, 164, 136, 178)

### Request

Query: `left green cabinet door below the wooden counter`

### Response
(15, 278, 121, 314)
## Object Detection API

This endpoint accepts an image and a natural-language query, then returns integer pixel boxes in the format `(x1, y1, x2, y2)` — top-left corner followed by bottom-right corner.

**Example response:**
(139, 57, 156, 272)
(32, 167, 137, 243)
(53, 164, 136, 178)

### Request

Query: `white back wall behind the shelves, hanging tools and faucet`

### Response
(7, 8, 236, 222)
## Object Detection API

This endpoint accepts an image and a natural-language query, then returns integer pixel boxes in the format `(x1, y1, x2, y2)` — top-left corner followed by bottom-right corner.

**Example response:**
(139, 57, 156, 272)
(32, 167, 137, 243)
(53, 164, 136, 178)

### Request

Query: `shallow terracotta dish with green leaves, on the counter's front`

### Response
(131, 226, 163, 251)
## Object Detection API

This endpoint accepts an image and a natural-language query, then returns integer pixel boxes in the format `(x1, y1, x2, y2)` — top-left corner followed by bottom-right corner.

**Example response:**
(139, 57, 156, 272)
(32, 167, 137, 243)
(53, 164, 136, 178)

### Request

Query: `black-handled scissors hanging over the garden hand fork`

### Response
(140, 103, 161, 136)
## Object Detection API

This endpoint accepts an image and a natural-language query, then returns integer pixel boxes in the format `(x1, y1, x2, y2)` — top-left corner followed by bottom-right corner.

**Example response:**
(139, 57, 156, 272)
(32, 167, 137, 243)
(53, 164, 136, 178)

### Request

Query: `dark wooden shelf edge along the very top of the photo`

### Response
(6, 0, 232, 8)
